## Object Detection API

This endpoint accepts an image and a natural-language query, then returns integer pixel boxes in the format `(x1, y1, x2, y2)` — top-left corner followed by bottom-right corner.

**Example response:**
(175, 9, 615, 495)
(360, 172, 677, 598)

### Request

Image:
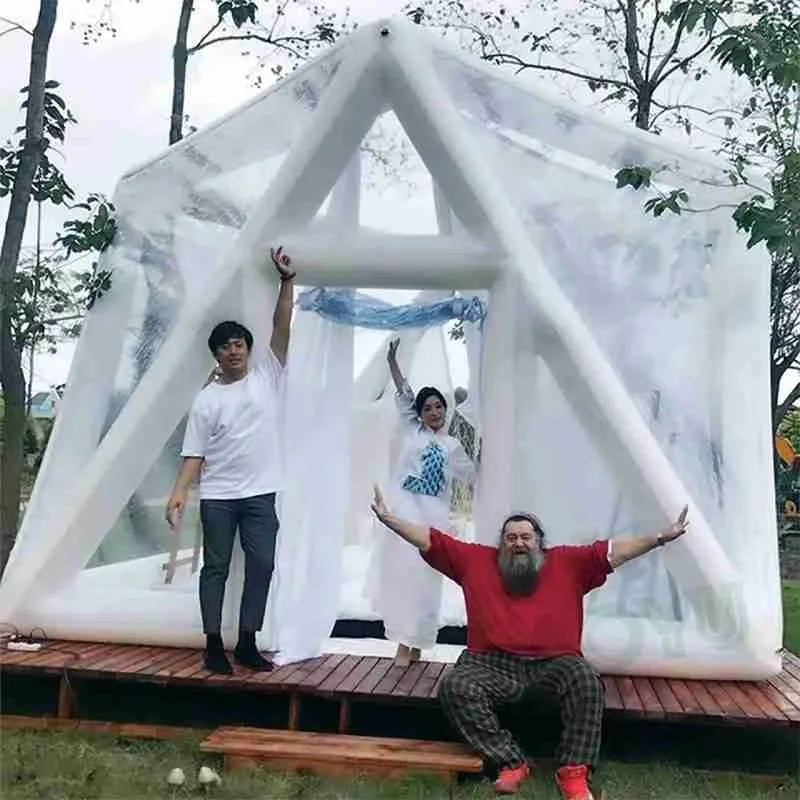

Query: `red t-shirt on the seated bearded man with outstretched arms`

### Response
(422, 528, 612, 658)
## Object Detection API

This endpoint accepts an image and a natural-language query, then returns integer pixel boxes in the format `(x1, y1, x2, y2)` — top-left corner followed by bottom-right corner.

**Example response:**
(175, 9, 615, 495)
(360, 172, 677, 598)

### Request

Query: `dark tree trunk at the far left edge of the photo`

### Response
(0, 0, 58, 573)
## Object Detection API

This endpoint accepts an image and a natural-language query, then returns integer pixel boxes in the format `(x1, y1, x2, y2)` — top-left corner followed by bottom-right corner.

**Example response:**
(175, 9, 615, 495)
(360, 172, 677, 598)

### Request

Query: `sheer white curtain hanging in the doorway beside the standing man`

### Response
(260, 313, 353, 663)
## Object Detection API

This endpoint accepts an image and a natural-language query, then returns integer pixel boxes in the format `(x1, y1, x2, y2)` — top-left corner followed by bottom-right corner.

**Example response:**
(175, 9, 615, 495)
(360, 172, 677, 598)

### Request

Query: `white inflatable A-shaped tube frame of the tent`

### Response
(0, 19, 781, 679)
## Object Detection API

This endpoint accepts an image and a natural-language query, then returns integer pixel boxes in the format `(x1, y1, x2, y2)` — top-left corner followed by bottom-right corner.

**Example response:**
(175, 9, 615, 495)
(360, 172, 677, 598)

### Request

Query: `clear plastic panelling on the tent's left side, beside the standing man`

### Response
(89, 53, 340, 566)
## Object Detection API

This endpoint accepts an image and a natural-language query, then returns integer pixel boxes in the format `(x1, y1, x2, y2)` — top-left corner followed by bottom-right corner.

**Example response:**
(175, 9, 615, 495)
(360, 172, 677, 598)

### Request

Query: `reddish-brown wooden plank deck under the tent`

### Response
(0, 641, 800, 733)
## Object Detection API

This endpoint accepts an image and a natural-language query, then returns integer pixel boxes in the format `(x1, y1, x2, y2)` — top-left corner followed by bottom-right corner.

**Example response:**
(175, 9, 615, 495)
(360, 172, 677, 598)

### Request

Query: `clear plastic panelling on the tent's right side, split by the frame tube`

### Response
(442, 60, 769, 620)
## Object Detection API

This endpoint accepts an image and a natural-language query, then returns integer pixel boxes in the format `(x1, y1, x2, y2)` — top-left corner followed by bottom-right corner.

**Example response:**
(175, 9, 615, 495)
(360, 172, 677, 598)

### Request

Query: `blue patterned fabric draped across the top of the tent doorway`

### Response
(297, 287, 486, 331)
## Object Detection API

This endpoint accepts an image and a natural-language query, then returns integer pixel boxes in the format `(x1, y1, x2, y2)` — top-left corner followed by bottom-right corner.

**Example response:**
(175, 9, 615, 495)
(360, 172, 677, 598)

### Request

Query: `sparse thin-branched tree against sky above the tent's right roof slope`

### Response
(406, 0, 734, 133)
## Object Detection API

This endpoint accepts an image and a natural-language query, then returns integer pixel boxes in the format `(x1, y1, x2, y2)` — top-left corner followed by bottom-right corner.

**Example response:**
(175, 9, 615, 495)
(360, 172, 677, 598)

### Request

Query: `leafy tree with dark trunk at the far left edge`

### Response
(0, 0, 116, 573)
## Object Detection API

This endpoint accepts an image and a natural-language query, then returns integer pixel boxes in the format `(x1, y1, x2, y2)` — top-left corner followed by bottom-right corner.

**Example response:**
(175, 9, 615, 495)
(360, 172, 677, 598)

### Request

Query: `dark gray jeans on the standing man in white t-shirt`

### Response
(200, 492, 278, 634)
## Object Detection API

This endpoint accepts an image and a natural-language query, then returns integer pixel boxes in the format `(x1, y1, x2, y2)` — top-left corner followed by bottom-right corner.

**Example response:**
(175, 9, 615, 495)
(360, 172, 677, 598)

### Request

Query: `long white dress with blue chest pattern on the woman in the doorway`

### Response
(372, 384, 475, 649)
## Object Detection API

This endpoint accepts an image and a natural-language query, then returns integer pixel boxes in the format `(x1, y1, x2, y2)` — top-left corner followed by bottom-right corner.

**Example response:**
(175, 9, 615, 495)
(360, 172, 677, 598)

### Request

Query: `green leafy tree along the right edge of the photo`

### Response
(617, 0, 800, 431)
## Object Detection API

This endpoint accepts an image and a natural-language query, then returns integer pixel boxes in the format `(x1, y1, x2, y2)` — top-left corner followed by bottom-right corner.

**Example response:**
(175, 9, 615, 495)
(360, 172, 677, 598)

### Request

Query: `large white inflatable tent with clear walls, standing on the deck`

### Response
(0, 19, 782, 679)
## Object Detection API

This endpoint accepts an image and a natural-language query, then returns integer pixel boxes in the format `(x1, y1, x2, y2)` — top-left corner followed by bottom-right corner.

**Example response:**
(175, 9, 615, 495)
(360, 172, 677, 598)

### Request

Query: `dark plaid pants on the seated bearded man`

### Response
(439, 650, 604, 769)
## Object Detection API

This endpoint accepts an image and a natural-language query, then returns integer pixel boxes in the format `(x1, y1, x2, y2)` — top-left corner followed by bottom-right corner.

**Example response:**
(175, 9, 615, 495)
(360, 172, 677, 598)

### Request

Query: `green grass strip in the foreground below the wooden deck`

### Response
(0, 732, 800, 800)
